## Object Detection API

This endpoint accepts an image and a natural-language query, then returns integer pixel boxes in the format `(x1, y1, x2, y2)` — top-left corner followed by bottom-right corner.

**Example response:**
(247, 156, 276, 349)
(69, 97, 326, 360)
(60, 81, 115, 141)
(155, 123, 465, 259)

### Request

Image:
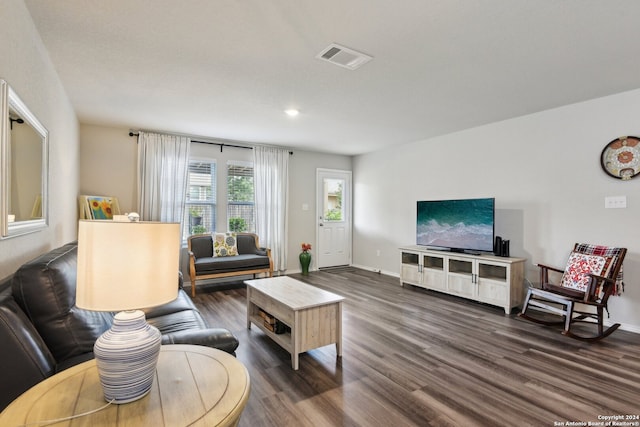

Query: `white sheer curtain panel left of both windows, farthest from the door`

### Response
(138, 132, 191, 223)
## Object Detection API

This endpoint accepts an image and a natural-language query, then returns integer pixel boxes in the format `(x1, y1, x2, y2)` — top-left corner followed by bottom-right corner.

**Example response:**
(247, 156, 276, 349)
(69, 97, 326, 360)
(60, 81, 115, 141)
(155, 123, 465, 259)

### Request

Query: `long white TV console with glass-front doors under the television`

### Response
(400, 245, 526, 314)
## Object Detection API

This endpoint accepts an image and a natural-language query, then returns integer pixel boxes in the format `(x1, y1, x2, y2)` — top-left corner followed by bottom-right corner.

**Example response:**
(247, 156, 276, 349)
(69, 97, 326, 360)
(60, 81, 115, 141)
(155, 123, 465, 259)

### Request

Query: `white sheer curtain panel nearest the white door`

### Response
(253, 146, 289, 271)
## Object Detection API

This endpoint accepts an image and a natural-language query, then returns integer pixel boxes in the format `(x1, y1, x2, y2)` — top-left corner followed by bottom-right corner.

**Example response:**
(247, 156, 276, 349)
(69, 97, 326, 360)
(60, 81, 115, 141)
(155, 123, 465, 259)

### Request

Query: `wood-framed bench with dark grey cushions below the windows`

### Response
(187, 233, 273, 297)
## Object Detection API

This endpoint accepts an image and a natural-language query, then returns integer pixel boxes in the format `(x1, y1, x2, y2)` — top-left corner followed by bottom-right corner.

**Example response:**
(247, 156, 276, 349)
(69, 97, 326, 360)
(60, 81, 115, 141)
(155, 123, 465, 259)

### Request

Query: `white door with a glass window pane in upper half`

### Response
(316, 169, 352, 268)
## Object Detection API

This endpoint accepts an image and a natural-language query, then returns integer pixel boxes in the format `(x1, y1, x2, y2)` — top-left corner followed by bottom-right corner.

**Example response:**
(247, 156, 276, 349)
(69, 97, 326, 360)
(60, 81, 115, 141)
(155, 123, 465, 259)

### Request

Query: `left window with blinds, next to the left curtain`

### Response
(182, 160, 216, 239)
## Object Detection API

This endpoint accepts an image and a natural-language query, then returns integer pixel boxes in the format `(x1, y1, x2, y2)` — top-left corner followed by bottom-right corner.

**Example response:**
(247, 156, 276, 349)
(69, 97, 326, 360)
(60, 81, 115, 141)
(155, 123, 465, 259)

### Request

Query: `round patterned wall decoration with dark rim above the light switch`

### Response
(600, 136, 640, 180)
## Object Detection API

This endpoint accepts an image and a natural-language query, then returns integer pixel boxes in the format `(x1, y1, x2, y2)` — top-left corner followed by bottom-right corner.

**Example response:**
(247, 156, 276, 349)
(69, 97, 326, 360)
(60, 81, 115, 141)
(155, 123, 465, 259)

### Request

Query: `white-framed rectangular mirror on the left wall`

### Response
(0, 80, 49, 238)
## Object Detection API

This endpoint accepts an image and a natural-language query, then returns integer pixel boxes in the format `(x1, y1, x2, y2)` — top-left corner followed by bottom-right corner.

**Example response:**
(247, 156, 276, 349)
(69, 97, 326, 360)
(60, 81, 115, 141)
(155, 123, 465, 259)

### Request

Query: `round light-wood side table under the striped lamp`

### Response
(0, 345, 250, 427)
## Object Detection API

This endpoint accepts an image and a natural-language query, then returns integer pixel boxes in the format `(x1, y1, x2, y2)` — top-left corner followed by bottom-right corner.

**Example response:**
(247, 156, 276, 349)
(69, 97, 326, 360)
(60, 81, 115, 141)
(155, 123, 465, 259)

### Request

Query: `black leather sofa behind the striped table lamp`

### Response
(0, 243, 238, 410)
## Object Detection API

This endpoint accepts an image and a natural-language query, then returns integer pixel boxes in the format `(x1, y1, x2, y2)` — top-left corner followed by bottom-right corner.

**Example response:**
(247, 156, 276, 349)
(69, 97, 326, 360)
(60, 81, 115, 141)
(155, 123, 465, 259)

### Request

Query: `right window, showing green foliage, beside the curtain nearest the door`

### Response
(227, 160, 256, 233)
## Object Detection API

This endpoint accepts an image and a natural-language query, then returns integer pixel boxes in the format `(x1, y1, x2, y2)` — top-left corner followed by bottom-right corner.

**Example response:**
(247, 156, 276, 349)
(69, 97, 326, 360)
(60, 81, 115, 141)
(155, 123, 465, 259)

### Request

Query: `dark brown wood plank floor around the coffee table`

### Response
(194, 268, 640, 427)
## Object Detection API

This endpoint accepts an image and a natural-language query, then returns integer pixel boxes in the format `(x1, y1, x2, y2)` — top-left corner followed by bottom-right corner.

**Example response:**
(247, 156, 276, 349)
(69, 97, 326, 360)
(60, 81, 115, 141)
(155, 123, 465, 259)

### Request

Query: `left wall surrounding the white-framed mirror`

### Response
(0, 0, 79, 278)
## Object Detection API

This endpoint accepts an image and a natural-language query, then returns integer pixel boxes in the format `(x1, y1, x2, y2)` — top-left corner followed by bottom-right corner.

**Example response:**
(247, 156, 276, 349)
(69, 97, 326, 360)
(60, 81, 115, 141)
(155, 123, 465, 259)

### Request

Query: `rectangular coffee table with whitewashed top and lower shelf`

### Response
(244, 276, 344, 370)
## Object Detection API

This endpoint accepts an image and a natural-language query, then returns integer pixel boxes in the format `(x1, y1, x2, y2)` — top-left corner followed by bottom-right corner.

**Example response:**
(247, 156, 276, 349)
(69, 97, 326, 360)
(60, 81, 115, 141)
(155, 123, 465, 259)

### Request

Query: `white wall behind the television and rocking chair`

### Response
(353, 90, 640, 332)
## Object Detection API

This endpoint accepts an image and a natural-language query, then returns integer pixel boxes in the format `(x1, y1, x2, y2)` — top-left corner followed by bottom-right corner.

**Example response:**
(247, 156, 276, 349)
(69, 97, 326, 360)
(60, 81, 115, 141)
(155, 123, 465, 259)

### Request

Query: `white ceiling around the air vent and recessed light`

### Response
(26, 0, 640, 154)
